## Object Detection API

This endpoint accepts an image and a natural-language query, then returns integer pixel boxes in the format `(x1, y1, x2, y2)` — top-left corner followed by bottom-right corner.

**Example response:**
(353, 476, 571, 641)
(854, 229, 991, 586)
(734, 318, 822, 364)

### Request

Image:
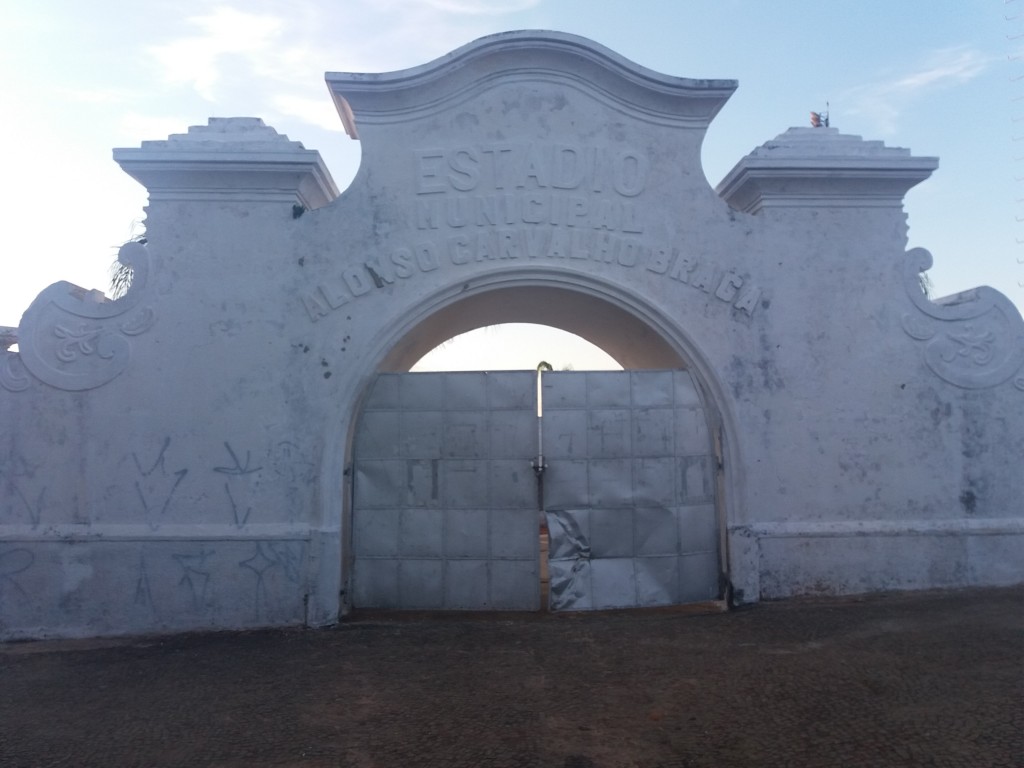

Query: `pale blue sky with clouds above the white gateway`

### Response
(0, 0, 1024, 368)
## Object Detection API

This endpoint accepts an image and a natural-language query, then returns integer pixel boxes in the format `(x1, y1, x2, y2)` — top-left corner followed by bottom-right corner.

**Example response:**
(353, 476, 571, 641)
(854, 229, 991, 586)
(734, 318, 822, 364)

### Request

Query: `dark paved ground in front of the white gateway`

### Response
(0, 589, 1024, 768)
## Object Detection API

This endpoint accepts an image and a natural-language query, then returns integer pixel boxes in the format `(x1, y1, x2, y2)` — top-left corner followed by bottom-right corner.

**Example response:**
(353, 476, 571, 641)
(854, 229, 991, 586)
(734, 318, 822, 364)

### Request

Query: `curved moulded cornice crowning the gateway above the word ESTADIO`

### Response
(326, 31, 736, 138)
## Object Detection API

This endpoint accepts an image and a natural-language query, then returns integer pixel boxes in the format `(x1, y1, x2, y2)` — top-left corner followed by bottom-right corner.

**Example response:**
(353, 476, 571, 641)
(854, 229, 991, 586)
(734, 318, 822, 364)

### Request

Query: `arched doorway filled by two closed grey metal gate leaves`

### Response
(347, 280, 727, 610)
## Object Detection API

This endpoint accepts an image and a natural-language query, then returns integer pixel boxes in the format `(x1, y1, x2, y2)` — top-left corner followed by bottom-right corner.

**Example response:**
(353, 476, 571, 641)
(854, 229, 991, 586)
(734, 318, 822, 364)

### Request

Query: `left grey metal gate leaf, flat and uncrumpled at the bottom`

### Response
(352, 372, 540, 610)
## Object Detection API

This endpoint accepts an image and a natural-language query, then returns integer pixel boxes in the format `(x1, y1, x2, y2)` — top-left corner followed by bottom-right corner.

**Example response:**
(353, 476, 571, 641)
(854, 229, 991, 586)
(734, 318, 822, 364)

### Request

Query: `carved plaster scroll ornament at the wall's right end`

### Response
(903, 248, 1024, 390)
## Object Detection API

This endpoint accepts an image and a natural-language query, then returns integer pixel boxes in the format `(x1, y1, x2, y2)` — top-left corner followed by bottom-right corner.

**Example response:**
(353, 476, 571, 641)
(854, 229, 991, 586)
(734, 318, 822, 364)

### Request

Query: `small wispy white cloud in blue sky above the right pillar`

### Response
(841, 47, 993, 133)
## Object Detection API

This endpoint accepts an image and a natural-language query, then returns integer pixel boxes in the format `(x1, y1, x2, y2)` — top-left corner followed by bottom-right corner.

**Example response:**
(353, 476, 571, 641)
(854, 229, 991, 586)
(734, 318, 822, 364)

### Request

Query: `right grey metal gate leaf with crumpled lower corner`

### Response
(544, 371, 720, 610)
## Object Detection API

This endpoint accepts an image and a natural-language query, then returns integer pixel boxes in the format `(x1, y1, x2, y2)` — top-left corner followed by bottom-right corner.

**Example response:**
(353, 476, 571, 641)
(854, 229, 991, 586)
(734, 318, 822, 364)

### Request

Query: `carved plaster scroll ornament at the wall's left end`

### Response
(0, 243, 155, 392)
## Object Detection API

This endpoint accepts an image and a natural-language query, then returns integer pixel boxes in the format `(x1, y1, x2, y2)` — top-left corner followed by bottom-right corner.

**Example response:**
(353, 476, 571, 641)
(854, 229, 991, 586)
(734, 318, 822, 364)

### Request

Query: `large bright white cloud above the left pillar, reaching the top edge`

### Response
(147, 0, 540, 131)
